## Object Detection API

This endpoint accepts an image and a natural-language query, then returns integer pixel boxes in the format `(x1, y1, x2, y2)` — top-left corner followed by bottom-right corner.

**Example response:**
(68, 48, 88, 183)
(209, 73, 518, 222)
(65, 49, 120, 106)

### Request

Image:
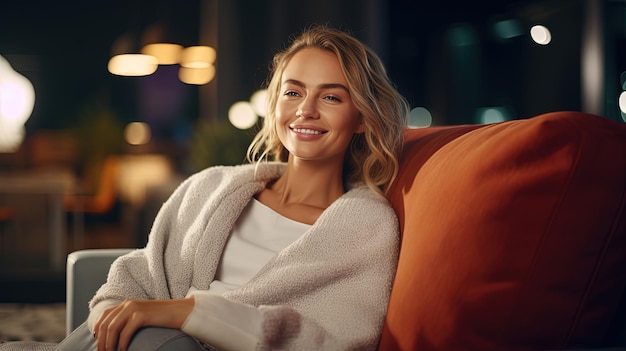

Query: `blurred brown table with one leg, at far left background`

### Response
(0, 170, 75, 271)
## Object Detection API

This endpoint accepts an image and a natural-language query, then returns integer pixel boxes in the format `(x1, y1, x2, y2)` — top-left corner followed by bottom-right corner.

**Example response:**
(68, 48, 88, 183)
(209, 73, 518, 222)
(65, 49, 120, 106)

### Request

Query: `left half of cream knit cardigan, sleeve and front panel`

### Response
(89, 163, 284, 322)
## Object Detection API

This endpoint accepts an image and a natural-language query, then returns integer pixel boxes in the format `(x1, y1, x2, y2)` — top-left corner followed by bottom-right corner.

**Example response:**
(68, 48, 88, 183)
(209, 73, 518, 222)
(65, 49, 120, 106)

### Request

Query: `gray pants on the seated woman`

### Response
(0, 323, 211, 351)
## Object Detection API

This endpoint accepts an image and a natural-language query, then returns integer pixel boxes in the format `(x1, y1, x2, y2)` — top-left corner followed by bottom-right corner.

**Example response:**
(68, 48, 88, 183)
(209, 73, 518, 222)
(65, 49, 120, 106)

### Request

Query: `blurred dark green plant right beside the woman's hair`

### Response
(189, 121, 254, 172)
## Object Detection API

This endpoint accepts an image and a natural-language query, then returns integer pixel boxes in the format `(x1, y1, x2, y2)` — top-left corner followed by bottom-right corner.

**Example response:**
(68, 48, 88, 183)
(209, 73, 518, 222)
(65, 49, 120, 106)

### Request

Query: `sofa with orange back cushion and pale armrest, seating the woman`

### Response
(67, 111, 626, 351)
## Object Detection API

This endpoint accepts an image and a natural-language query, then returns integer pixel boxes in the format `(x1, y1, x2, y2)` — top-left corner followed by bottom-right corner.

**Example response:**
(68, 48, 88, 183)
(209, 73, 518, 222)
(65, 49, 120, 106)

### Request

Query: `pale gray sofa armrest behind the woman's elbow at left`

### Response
(65, 249, 134, 334)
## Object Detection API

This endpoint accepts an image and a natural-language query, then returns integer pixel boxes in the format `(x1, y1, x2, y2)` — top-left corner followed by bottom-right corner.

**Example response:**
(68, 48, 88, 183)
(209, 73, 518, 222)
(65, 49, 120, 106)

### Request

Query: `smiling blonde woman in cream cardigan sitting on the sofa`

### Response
(1, 26, 408, 351)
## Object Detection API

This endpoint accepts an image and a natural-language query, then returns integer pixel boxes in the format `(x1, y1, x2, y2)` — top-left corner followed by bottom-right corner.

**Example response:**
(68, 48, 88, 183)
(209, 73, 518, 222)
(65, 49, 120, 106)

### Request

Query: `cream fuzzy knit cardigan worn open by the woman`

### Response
(90, 163, 399, 350)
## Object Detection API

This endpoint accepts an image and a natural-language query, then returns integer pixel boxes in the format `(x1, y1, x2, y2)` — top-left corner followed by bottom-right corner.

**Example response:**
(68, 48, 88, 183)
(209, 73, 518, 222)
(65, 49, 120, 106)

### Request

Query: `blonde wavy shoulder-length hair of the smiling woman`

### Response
(247, 25, 409, 193)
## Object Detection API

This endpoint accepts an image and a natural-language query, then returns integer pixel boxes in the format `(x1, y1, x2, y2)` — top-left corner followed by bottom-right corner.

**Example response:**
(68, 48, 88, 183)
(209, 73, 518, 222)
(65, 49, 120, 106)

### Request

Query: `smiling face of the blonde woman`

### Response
(275, 48, 363, 167)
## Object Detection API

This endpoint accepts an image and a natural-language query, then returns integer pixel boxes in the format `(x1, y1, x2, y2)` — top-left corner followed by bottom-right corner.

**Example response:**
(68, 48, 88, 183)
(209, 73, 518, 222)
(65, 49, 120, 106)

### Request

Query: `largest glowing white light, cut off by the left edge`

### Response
(0, 56, 35, 152)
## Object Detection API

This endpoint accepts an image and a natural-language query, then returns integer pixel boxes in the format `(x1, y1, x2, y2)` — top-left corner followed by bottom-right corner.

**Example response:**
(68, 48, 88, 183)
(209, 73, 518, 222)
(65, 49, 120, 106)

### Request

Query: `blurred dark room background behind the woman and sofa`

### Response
(0, 0, 626, 301)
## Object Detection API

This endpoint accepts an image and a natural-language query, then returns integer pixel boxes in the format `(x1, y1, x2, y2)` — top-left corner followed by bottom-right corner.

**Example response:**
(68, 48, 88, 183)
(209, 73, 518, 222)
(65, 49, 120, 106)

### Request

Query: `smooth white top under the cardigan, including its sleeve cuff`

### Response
(181, 198, 311, 350)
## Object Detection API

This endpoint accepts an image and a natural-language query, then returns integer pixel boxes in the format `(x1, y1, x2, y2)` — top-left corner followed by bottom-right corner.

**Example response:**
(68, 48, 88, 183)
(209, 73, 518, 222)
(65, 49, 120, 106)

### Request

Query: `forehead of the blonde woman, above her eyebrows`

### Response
(282, 48, 347, 84)
